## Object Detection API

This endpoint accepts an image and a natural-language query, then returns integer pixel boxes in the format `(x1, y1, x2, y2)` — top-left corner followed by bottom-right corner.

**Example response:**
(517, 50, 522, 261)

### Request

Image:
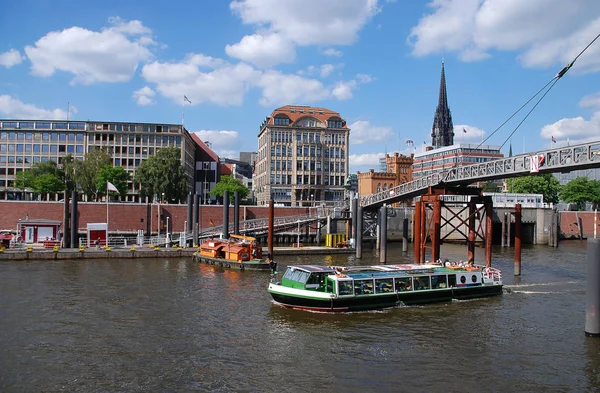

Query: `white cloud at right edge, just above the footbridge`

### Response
(540, 92, 600, 144)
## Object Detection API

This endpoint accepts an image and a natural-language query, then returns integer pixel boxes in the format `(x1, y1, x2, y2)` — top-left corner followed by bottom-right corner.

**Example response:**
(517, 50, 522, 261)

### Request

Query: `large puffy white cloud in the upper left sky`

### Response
(25, 17, 155, 85)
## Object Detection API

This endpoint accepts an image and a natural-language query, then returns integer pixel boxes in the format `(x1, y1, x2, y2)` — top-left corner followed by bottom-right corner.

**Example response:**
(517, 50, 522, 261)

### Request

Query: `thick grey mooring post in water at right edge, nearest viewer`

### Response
(585, 238, 600, 337)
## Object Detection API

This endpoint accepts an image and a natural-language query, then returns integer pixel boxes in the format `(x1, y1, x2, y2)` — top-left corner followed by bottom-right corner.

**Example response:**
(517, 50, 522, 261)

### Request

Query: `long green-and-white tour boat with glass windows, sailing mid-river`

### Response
(268, 264, 502, 312)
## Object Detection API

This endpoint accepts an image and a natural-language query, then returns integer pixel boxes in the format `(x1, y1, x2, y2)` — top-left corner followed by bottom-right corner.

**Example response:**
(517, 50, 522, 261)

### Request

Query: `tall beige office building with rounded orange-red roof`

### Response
(254, 105, 350, 206)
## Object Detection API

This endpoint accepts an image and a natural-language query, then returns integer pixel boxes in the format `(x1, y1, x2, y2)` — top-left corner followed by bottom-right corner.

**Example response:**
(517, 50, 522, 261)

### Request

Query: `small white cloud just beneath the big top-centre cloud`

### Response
(225, 34, 296, 68)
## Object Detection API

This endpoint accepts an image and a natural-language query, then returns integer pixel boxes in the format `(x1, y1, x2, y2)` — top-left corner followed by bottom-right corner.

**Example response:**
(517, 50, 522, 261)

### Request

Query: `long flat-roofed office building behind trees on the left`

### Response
(0, 120, 196, 202)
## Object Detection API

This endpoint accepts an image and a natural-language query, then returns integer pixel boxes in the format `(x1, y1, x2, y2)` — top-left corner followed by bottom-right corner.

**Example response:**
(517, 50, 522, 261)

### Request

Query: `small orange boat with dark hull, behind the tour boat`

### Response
(194, 235, 277, 271)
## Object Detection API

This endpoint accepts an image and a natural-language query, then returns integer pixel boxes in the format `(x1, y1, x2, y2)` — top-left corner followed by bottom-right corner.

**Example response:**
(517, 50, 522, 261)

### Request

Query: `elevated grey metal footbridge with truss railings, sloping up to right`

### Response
(359, 141, 600, 210)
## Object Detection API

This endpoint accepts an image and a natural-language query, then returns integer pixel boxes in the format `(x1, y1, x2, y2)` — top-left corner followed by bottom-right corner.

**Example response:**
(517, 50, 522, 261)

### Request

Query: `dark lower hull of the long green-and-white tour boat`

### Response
(269, 285, 502, 312)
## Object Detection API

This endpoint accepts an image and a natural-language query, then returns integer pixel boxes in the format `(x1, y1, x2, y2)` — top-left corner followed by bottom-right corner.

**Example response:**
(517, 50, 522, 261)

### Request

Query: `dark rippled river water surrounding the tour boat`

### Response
(0, 242, 600, 392)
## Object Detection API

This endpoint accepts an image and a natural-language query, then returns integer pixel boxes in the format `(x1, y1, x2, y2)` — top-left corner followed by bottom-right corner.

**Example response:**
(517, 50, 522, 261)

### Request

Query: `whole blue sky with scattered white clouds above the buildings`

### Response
(0, 0, 600, 172)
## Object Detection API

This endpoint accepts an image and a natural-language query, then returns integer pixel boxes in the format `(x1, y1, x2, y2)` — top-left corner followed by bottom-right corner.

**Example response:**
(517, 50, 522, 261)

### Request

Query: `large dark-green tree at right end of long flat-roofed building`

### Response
(133, 146, 188, 202)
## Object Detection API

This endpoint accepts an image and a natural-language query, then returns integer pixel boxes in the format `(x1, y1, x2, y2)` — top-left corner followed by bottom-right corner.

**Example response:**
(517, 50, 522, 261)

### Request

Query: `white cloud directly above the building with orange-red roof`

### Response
(258, 71, 330, 106)
